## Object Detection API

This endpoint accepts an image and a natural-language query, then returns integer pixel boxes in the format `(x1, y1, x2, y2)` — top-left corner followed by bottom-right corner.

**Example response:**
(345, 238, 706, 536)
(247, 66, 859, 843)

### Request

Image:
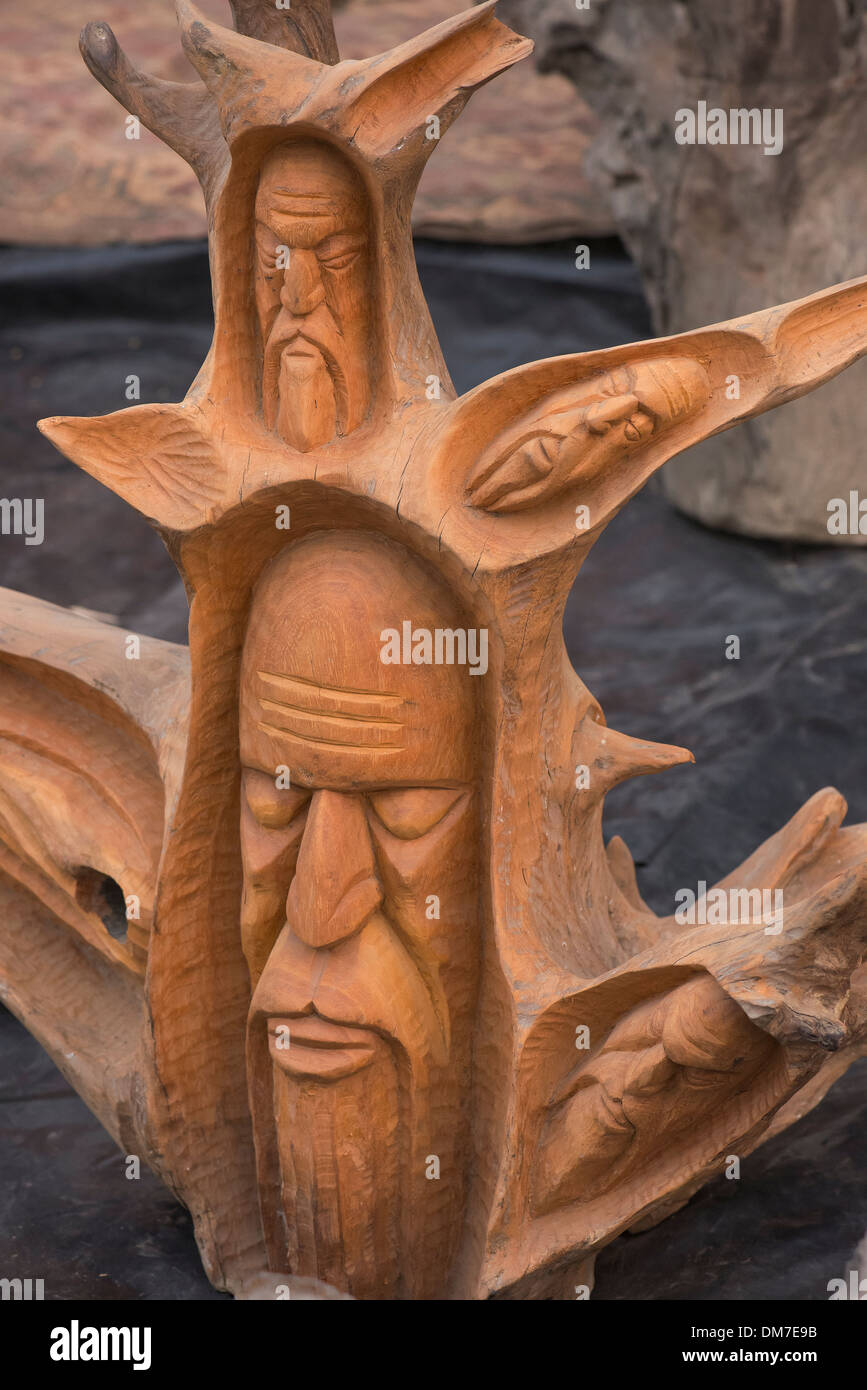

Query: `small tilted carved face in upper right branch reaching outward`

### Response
(467, 357, 709, 512)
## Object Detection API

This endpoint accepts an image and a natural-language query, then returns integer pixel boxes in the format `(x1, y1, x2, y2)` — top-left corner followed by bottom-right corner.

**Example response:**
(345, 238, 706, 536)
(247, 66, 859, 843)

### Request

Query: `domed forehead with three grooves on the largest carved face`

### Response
(240, 531, 477, 785)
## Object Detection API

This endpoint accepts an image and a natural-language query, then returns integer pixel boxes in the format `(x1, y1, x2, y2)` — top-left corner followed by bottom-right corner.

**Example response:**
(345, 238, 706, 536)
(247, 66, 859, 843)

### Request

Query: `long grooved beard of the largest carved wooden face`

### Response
(250, 1016, 468, 1300)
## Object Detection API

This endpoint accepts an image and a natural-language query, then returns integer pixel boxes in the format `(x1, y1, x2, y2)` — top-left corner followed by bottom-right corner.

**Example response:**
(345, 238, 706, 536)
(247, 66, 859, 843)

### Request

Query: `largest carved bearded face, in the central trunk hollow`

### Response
(240, 535, 481, 1297)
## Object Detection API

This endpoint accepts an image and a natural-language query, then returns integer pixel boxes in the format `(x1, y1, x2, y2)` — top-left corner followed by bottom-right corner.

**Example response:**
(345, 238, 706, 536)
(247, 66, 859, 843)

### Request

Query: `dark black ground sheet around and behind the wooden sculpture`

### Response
(0, 243, 867, 1300)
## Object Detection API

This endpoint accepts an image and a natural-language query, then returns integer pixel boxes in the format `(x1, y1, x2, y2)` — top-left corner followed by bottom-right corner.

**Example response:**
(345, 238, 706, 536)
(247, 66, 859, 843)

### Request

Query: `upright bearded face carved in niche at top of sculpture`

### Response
(254, 142, 371, 452)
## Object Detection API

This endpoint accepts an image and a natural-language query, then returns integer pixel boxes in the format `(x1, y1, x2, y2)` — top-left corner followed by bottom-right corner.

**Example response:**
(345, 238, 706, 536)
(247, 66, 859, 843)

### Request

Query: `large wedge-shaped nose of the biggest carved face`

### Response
(286, 791, 382, 947)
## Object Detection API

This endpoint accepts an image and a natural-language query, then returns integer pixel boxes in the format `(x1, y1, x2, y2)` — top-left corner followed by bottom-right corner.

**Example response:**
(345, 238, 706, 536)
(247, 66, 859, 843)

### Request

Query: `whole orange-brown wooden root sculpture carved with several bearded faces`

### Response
(0, 0, 867, 1298)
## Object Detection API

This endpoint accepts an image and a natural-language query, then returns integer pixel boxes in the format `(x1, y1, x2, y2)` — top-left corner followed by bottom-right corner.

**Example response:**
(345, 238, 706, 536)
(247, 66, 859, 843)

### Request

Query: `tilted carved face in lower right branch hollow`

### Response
(534, 976, 781, 1213)
